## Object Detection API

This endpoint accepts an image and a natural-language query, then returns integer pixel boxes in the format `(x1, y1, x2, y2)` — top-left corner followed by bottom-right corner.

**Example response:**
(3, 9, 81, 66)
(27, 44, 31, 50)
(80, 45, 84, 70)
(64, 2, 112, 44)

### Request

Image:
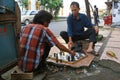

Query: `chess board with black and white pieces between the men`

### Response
(48, 51, 88, 64)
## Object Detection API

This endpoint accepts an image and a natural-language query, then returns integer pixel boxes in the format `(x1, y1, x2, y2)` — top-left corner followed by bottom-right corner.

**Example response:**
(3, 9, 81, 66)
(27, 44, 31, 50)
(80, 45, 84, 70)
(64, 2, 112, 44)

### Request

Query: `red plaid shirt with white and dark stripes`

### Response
(18, 24, 59, 72)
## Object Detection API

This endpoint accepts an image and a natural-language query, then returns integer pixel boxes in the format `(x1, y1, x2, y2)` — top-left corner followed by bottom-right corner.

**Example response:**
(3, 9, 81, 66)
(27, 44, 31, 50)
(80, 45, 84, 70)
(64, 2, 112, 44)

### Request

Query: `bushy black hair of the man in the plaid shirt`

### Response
(33, 10, 53, 25)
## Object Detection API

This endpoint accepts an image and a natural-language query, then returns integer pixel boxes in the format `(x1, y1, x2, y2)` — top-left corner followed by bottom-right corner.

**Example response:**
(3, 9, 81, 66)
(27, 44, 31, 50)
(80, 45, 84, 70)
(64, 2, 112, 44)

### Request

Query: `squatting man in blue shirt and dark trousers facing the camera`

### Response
(60, 2, 99, 53)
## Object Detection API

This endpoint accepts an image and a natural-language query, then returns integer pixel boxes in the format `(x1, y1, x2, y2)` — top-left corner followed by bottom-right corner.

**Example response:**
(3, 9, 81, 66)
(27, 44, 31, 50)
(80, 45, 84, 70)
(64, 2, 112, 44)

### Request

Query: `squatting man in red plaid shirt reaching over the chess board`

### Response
(18, 10, 75, 72)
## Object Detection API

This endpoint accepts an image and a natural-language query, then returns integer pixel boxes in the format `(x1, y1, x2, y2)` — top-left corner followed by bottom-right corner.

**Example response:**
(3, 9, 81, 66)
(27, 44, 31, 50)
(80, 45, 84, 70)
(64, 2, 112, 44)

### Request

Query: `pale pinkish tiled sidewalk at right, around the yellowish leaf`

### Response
(100, 28, 120, 63)
